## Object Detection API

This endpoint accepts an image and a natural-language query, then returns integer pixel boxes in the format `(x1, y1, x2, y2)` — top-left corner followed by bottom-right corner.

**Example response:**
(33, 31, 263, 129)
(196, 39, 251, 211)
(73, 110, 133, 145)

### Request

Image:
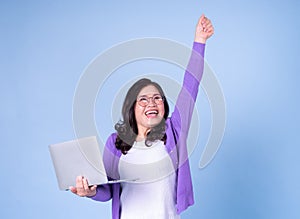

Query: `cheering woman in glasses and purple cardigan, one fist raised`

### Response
(70, 15, 214, 219)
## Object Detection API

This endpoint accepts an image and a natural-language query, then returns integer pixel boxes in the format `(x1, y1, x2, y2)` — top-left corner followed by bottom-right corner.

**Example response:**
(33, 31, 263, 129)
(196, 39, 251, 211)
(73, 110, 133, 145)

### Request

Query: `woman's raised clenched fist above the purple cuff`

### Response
(195, 14, 214, 43)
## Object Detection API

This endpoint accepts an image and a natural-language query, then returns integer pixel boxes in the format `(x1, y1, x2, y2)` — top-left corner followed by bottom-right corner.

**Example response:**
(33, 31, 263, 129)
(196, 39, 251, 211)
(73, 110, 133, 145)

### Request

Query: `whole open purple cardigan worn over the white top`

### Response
(91, 42, 205, 219)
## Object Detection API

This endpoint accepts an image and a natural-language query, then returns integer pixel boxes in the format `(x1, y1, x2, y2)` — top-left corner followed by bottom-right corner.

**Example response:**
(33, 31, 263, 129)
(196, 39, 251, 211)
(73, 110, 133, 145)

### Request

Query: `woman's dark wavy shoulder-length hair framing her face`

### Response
(115, 78, 169, 154)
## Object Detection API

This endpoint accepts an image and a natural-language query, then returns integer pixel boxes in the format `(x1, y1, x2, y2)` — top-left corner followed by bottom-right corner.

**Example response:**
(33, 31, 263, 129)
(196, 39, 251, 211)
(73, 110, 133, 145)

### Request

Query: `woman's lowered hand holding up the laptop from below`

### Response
(70, 176, 97, 197)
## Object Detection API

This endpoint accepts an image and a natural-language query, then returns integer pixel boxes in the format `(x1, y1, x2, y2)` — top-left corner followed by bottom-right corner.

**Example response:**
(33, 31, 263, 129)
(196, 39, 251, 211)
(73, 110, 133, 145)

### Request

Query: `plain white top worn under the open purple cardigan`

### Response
(119, 141, 180, 219)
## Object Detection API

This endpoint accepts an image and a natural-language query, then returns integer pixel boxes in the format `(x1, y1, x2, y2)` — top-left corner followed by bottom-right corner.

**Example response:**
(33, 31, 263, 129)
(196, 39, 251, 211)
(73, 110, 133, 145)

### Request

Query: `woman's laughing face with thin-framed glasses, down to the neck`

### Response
(135, 85, 165, 135)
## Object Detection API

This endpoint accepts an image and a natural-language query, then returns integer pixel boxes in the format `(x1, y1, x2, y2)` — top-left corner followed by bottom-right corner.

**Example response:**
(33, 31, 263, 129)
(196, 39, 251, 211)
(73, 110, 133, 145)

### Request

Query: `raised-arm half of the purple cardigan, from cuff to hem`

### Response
(167, 42, 205, 214)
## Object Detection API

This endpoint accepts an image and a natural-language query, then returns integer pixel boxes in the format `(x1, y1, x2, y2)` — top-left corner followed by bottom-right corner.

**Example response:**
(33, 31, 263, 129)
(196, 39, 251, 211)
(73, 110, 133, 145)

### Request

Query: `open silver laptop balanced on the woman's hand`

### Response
(49, 136, 137, 190)
